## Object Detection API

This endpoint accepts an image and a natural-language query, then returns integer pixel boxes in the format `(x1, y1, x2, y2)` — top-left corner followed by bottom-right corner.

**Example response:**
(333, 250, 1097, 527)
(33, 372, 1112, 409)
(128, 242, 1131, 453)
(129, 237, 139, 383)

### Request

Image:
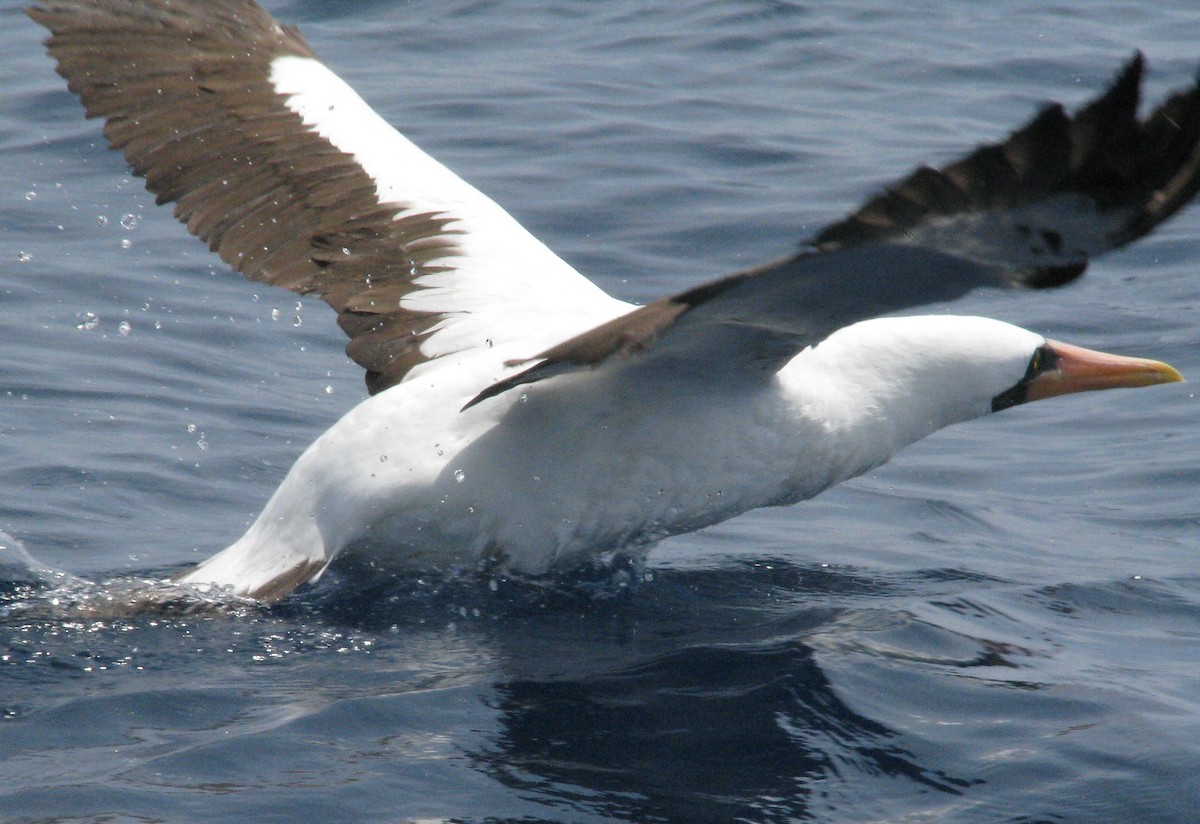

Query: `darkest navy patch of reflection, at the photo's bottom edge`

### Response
(473, 639, 967, 820)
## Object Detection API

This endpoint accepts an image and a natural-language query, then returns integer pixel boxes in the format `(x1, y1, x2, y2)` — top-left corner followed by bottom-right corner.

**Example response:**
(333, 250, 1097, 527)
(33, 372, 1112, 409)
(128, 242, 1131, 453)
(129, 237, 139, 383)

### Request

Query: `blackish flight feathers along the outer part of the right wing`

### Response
(811, 52, 1200, 288)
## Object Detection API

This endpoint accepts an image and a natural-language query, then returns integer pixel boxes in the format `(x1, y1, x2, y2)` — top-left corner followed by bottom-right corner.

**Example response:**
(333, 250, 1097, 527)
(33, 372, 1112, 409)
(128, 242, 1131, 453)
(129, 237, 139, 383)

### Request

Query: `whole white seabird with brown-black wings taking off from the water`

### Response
(30, 0, 1200, 601)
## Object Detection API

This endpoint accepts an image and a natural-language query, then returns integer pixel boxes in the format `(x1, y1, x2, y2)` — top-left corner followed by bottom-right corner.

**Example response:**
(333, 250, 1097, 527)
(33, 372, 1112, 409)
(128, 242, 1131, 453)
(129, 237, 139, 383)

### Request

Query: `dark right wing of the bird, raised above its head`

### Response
(468, 54, 1200, 405)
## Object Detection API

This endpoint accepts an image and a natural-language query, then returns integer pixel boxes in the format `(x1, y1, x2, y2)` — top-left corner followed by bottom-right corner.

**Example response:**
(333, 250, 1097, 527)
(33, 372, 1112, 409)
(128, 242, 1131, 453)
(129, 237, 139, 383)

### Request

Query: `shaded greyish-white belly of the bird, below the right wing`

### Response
(333, 375, 827, 573)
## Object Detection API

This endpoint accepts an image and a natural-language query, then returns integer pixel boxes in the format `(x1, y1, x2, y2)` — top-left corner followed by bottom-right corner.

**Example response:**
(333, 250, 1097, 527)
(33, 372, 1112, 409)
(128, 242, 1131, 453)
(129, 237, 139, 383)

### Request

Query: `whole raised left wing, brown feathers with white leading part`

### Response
(29, 0, 631, 392)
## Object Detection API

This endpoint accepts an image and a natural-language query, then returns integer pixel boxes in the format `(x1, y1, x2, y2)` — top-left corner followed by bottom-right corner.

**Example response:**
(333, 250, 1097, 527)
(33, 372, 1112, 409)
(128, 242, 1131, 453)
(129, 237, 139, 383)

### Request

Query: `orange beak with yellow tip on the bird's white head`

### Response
(1025, 341, 1183, 401)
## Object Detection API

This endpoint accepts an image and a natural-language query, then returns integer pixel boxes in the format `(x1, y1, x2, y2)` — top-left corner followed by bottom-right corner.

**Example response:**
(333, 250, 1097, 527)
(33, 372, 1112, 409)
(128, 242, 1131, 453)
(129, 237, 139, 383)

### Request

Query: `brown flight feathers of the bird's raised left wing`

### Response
(29, 0, 455, 392)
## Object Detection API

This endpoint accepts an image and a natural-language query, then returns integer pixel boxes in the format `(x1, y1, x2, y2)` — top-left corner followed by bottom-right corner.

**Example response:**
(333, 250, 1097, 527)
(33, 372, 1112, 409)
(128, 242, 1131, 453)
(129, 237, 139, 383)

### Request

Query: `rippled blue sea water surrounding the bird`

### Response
(0, 0, 1200, 823)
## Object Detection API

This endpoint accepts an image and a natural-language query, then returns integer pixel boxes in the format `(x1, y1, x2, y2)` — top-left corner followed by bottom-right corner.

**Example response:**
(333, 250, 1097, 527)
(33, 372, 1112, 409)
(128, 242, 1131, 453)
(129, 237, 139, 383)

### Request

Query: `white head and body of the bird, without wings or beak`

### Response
(192, 315, 1045, 591)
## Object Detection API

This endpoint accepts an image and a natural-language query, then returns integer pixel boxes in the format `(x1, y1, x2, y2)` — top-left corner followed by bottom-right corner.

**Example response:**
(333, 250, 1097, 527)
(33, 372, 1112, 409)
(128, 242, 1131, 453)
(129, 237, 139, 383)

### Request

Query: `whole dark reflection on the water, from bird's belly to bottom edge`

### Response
(436, 563, 972, 820)
